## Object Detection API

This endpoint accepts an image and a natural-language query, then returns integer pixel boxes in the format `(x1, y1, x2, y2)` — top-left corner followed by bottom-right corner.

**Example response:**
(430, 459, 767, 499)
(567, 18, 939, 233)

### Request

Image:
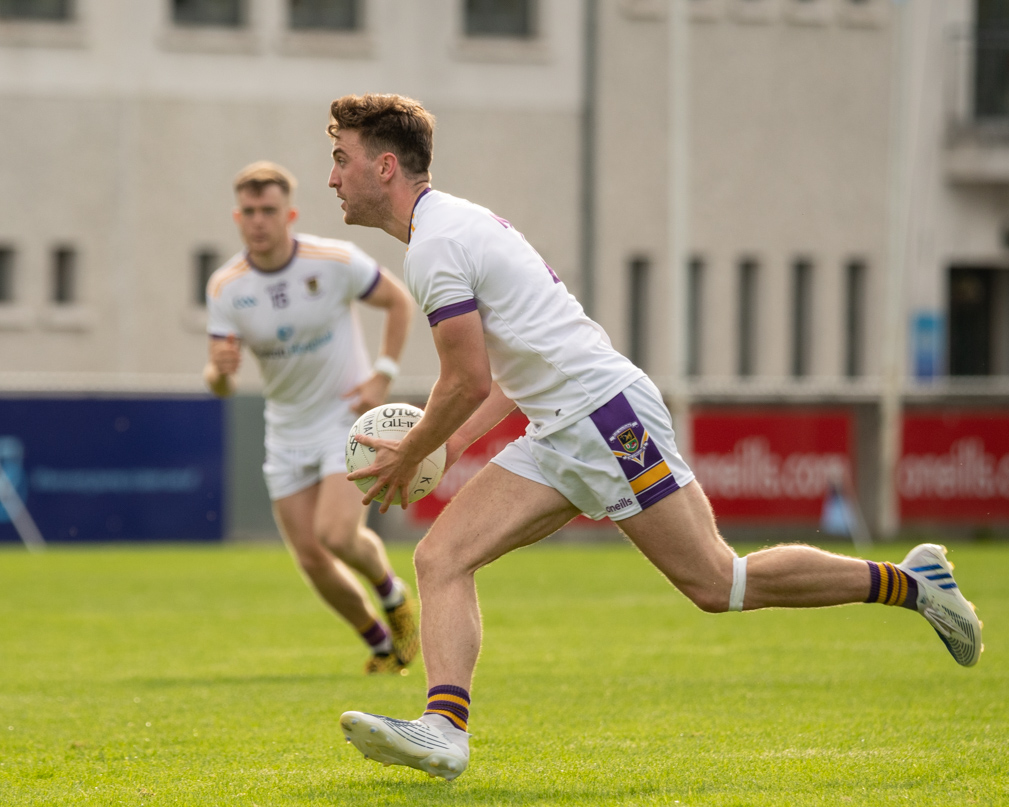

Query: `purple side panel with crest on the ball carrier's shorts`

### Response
(589, 392, 680, 509)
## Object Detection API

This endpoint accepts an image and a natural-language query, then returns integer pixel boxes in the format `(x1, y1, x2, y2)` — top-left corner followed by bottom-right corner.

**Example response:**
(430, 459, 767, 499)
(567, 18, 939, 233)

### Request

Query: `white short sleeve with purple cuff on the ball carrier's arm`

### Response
(406, 238, 476, 325)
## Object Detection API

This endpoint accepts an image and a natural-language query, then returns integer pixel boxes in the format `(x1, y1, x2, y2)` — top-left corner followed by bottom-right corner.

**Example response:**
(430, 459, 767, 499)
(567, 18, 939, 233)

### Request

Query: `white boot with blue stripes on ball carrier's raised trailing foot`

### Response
(897, 544, 985, 667)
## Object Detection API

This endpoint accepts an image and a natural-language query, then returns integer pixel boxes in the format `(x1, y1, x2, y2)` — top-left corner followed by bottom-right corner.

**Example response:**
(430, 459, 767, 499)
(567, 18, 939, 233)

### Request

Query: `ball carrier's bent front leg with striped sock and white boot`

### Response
(340, 463, 578, 779)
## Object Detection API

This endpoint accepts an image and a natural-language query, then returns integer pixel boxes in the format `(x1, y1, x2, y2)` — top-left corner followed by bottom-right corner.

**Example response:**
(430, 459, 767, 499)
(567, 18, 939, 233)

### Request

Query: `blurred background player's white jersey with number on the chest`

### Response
(207, 235, 380, 446)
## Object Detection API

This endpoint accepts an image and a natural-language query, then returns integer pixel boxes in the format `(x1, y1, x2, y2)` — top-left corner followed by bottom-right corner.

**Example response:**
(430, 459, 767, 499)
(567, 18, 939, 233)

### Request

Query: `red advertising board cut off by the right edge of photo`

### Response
(897, 410, 1009, 524)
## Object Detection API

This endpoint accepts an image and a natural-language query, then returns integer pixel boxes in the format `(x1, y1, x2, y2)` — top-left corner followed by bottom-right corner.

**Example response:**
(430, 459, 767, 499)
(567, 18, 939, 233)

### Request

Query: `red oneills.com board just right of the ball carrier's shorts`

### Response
(691, 409, 855, 524)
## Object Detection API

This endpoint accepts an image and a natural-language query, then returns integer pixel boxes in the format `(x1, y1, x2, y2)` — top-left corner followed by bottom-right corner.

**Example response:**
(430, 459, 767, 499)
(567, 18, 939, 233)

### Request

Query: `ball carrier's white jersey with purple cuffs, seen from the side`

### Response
(405, 191, 645, 437)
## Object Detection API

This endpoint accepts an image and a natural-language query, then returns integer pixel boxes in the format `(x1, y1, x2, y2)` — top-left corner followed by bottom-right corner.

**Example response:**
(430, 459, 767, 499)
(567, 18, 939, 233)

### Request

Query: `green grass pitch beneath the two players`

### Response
(0, 542, 1009, 807)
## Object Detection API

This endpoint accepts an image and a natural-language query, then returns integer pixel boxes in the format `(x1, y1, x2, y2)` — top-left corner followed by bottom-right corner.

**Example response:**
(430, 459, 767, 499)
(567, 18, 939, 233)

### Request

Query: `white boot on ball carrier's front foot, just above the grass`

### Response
(340, 712, 469, 780)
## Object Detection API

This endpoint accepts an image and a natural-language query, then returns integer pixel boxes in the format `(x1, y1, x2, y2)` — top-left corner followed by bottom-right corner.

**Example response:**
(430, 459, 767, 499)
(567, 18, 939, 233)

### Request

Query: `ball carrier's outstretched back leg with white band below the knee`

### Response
(619, 481, 981, 666)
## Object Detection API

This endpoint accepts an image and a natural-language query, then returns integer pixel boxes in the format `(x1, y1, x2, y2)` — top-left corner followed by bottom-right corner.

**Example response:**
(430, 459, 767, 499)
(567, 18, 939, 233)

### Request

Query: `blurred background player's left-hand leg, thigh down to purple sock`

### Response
(273, 484, 403, 672)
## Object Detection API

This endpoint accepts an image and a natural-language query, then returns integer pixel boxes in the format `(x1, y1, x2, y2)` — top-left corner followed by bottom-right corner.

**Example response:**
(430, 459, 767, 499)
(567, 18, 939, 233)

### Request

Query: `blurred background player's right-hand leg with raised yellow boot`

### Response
(315, 469, 420, 672)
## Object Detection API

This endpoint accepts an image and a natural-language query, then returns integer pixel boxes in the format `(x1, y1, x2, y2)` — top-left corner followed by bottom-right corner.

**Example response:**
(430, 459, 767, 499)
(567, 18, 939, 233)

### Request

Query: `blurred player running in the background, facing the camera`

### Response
(204, 162, 419, 673)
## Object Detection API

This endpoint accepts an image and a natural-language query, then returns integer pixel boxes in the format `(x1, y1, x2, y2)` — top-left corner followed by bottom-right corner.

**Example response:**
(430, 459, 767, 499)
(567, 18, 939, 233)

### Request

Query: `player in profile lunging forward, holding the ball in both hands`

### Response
(329, 95, 982, 779)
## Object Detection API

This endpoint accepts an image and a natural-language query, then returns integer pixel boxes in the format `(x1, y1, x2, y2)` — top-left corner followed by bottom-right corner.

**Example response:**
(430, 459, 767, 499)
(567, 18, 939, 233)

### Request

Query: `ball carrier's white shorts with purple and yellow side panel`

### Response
(491, 378, 694, 522)
